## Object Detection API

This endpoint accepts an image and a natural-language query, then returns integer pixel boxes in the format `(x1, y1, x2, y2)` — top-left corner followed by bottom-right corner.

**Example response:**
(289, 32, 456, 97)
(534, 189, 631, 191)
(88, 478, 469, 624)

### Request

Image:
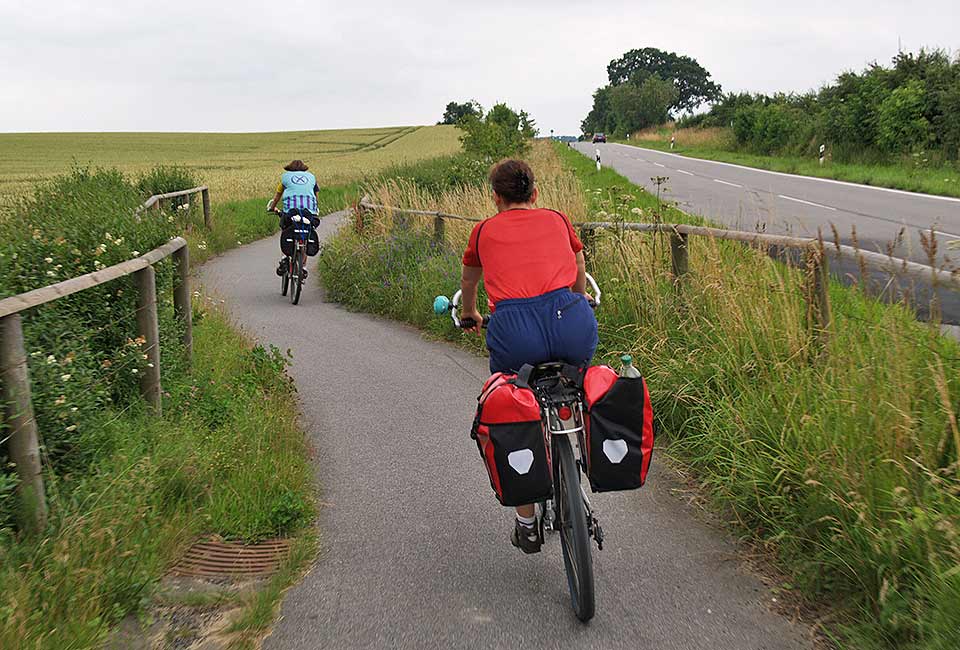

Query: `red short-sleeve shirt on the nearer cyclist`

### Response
(463, 208, 583, 305)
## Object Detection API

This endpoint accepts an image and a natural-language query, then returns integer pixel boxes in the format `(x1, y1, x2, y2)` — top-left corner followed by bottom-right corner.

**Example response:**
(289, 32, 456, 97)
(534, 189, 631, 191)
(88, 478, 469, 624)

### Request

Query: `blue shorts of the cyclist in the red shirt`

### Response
(487, 289, 598, 373)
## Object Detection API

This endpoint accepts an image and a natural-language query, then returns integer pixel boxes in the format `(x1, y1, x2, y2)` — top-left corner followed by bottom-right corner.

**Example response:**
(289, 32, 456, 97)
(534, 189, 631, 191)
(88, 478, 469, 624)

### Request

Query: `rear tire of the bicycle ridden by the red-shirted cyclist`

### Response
(552, 436, 596, 623)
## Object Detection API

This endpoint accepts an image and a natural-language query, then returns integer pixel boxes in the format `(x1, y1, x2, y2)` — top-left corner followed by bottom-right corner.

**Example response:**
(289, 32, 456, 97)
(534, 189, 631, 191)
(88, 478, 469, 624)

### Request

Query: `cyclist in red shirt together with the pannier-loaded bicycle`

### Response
(434, 160, 653, 621)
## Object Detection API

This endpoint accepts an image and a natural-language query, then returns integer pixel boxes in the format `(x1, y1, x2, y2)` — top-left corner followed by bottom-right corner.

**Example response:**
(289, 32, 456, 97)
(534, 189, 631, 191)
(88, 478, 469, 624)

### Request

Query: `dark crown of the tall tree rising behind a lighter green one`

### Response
(607, 47, 721, 112)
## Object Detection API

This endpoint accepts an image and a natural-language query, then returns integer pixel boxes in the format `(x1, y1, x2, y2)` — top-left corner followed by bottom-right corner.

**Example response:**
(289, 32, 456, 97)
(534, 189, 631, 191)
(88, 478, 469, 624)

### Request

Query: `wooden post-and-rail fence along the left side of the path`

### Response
(0, 186, 211, 530)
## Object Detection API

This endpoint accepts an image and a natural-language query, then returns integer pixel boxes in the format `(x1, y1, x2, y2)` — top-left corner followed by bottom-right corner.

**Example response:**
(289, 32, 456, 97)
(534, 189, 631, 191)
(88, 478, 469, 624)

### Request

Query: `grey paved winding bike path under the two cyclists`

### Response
(201, 210, 811, 650)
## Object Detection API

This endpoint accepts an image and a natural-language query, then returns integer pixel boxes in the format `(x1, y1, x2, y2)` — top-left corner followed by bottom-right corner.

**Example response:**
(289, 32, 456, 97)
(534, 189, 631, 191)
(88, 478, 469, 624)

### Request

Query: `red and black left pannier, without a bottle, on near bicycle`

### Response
(470, 372, 553, 506)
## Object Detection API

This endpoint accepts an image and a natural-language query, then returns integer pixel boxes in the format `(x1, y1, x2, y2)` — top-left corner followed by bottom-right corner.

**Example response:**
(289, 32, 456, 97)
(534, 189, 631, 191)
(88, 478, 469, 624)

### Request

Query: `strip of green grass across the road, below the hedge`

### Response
(624, 140, 960, 197)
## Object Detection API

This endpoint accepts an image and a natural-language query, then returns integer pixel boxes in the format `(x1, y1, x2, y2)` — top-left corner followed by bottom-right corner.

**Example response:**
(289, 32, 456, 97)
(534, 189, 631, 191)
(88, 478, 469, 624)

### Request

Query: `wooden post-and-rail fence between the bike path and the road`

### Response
(357, 196, 960, 344)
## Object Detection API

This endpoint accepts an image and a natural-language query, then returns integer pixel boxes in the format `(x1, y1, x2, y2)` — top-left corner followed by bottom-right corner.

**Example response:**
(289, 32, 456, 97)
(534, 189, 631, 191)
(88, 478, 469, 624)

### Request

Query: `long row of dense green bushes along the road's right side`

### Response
(681, 50, 960, 160)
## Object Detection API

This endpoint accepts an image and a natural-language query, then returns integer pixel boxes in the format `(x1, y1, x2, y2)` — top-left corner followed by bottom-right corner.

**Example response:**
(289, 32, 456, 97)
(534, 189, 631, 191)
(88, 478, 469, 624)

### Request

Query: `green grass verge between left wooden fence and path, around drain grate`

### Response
(0, 312, 313, 650)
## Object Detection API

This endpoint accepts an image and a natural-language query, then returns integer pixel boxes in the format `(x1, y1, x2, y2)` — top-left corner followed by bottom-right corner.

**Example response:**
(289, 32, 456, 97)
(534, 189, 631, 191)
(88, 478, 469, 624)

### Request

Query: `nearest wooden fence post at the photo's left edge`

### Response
(0, 314, 47, 532)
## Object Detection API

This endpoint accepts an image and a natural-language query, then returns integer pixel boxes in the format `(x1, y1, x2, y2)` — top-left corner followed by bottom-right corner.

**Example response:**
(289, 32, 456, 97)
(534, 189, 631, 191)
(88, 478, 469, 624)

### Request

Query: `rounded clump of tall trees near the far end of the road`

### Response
(581, 47, 721, 136)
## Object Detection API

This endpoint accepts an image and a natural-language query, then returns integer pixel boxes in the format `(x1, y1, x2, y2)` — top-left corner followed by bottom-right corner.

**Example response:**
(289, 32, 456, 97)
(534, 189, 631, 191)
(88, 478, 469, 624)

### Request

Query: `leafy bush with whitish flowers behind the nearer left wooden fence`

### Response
(0, 168, 178, 519)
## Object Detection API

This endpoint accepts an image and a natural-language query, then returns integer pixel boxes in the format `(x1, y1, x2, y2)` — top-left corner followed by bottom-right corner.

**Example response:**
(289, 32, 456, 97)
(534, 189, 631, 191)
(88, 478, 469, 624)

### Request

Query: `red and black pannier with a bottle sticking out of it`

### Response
(583, 366, 653, 492)
